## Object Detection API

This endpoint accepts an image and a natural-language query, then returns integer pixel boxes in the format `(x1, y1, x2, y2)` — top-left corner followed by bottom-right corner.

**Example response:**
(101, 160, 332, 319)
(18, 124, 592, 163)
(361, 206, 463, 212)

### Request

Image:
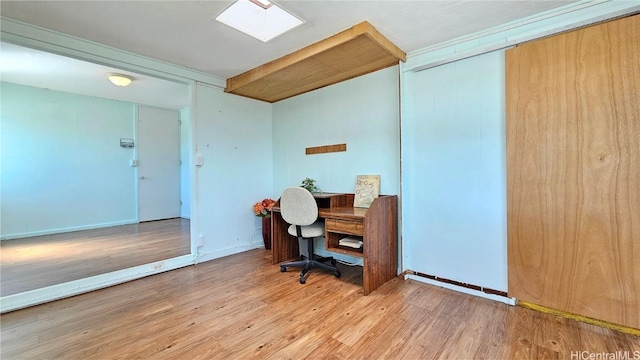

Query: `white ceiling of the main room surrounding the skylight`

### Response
(0, 0, 576, 107)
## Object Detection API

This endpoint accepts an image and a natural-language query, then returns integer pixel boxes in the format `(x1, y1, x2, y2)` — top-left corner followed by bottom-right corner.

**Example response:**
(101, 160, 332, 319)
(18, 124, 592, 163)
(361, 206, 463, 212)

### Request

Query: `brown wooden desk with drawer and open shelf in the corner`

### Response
(271, 193, 398, 295)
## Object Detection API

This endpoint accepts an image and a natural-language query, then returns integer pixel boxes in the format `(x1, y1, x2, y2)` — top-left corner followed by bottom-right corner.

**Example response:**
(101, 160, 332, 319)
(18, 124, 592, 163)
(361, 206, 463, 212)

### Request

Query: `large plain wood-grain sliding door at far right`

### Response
(506, 15, 640, 328)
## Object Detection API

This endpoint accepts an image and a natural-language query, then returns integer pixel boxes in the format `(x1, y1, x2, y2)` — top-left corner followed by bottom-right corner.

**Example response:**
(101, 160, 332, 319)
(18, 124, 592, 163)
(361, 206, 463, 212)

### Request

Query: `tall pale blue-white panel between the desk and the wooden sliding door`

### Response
(402, 51, 507, 291)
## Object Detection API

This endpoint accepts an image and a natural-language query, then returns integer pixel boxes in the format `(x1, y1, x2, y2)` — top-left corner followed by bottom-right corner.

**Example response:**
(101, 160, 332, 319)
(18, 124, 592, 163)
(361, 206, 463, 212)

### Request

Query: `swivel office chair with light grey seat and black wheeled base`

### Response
(280, 187, 340, 284)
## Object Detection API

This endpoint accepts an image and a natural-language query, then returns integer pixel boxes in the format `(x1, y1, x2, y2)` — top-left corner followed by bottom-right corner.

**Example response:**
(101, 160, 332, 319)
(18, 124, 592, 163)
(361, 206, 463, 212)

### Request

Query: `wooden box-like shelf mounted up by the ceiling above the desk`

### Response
(225, 21, 406, 102)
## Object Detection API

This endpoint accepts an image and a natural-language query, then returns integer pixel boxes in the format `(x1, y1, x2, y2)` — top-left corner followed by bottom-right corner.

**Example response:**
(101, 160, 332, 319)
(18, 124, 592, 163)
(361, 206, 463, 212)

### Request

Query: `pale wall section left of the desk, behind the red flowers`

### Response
(192, 85, 274, 261)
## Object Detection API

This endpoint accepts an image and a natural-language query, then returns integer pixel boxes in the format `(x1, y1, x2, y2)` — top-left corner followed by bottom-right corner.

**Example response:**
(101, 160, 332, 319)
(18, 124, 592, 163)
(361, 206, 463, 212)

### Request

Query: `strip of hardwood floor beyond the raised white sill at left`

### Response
(0, 218, 191, 296)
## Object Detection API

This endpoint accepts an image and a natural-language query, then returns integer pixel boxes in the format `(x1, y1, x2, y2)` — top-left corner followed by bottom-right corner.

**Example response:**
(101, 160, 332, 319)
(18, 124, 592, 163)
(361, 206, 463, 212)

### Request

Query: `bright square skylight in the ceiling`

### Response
(215, 0, 303, 42)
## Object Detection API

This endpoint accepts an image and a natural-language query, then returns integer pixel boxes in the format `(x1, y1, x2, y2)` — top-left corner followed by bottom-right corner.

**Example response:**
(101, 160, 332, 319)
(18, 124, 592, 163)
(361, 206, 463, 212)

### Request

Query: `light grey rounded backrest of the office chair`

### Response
(280, 186, 318, 226)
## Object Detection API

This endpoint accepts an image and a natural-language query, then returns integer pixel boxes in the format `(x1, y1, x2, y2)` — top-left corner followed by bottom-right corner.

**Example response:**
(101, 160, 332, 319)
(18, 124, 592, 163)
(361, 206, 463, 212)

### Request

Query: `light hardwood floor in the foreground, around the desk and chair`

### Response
(0, 250, 640, 360)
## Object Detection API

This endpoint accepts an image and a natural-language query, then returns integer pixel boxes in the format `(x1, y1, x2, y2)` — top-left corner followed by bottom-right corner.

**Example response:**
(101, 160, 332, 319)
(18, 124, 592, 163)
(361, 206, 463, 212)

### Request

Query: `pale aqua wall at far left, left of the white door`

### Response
(0, 83, 137, 238)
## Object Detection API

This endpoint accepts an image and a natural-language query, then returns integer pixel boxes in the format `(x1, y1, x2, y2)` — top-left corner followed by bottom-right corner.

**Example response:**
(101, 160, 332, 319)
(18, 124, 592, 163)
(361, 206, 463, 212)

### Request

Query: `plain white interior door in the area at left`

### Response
(138, 106, 180, 221)
